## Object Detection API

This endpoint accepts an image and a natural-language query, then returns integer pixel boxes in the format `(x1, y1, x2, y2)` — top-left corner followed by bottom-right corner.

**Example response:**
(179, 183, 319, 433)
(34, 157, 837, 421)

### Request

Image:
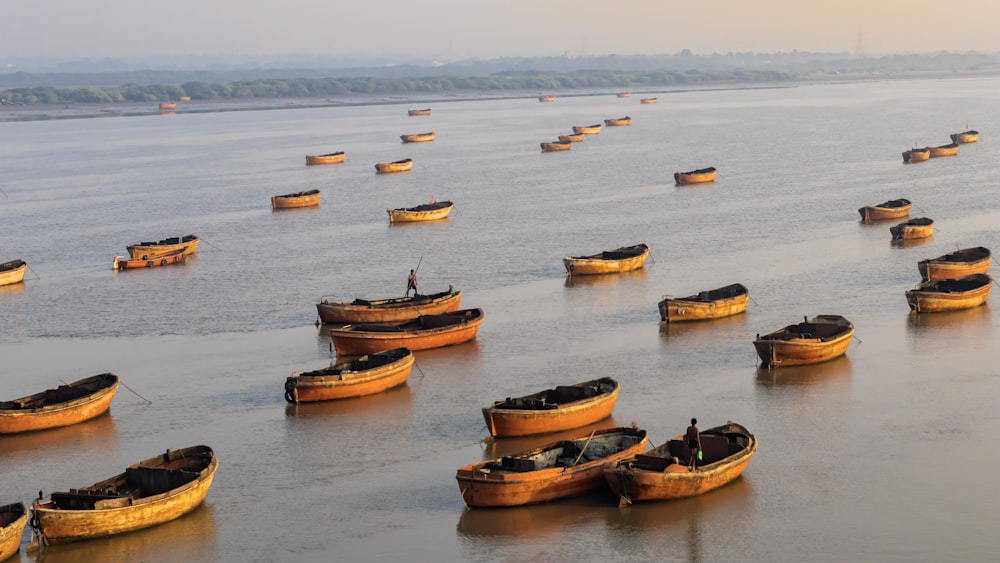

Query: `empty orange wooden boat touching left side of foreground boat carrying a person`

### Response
(455, 426, 649, 507)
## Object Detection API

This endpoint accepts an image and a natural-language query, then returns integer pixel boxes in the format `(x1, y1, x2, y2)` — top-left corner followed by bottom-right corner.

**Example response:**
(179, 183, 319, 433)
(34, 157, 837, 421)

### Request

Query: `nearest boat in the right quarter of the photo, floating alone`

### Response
(753, 315, 854, 367)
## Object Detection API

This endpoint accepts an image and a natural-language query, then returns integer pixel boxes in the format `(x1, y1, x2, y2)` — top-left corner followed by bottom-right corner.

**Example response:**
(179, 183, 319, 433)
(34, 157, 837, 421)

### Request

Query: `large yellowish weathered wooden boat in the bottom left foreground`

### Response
(31, 446, 219, 544)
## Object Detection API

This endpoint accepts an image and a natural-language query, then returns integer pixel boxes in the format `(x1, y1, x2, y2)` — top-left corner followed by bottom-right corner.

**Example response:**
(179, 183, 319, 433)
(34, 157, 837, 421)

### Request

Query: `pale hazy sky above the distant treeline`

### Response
(0, 0, 1000, 61)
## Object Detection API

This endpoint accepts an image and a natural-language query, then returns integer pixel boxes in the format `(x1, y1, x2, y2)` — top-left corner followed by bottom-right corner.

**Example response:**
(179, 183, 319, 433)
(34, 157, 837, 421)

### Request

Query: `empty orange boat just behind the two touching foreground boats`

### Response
(483, 377, 620, 438)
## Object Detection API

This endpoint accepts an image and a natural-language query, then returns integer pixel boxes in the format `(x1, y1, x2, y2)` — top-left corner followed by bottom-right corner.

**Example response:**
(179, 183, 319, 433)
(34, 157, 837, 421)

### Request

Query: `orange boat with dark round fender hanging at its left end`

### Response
(285, 348, 413, 403)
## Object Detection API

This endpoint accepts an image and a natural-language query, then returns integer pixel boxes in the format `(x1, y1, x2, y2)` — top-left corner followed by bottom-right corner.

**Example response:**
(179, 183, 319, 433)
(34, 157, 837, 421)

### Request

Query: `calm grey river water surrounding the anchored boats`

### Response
(0, 79, 1000, 562)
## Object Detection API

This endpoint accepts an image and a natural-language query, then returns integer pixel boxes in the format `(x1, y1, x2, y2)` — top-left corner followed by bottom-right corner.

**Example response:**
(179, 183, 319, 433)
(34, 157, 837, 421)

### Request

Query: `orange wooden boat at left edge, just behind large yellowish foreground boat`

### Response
(0, 373, 119, 434)
